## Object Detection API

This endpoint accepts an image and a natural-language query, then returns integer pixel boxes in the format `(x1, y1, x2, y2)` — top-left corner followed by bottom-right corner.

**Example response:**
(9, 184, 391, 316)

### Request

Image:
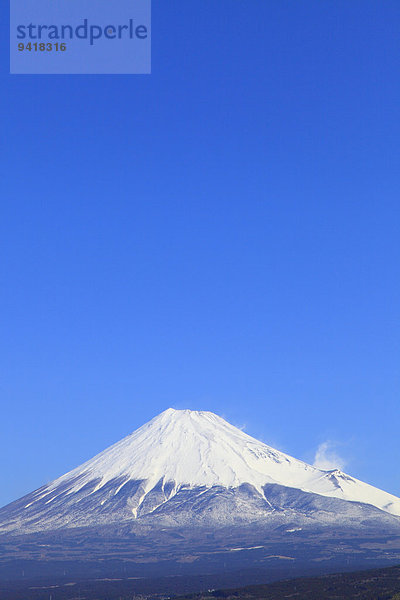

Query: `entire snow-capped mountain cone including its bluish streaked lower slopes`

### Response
(0, 409, 400, 533)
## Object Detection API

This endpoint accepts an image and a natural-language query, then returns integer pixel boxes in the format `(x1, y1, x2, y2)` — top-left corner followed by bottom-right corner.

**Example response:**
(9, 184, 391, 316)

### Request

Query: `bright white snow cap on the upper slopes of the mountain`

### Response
(36, 408, 400, 514)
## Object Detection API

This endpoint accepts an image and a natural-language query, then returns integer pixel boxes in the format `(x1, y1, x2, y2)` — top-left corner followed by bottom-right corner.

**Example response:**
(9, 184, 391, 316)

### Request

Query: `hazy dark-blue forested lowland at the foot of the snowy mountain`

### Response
(0, 525, 400, 600)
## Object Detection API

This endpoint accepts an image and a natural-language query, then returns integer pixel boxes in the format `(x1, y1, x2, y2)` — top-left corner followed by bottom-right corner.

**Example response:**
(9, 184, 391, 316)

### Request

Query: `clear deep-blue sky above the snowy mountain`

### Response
(0, 0, 400, 504)
